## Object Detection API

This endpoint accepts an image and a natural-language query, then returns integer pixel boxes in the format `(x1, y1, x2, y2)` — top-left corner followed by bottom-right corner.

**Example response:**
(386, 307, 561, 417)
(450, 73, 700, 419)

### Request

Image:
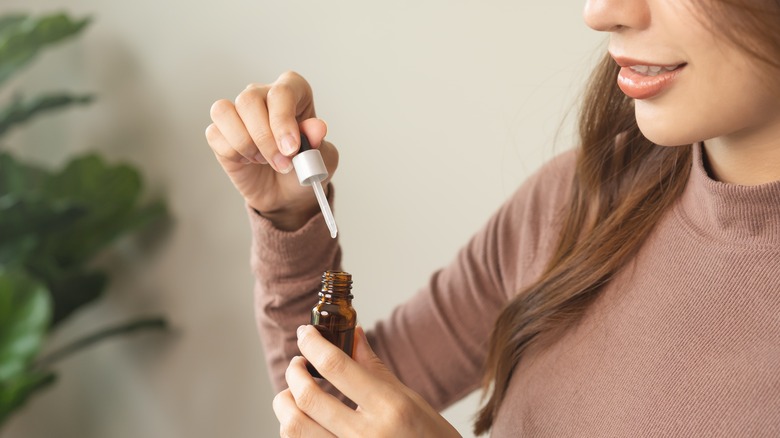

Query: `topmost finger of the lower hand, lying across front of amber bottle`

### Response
(297, 325, 394, 407)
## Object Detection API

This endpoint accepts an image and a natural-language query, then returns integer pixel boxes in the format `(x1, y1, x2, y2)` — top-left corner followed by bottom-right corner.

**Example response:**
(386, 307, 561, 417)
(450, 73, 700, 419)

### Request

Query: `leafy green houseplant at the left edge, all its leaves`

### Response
(0, 13, 167, 427)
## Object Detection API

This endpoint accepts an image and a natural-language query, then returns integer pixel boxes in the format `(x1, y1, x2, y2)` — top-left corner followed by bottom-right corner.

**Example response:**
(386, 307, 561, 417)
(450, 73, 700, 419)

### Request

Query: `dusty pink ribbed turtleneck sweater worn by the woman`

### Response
(250, 147, 780, 437)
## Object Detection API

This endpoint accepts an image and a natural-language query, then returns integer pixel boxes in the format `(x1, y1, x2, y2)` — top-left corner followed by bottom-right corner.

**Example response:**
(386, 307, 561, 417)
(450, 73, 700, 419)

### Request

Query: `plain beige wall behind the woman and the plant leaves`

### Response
(0, 0, 603, 438)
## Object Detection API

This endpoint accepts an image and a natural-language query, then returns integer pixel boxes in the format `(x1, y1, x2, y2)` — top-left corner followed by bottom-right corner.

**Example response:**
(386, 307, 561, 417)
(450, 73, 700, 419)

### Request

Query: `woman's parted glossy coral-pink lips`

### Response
(613, 56, 686, 100)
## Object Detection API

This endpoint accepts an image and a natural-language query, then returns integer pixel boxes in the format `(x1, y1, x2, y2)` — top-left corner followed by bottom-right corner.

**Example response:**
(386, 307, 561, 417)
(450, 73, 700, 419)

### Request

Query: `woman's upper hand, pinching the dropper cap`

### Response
(206, 72, 338, 231)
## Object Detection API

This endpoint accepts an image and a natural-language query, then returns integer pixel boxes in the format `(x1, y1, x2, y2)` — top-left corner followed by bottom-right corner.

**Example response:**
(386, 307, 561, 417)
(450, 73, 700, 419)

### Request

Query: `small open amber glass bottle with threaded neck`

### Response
(309, 271, 357, 377)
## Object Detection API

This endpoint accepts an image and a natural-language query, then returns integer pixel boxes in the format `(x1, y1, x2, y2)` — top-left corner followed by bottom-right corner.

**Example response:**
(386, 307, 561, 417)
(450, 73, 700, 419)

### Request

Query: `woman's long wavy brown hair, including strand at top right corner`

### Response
(474, 0, 780, 435)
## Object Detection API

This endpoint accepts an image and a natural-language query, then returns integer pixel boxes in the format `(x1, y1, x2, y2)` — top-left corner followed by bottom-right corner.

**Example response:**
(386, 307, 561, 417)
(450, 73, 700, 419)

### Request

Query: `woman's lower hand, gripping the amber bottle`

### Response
(274, 325, 460, 438)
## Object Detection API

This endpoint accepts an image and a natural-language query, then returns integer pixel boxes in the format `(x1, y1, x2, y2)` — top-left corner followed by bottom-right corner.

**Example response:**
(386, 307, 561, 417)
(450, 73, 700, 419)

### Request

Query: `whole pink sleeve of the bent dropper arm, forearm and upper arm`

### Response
(250, 154, 571, 409)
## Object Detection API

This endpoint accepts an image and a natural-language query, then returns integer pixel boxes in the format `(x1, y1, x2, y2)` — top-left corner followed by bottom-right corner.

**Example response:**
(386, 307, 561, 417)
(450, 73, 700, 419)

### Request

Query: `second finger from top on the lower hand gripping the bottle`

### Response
(285, 356, 357, 436)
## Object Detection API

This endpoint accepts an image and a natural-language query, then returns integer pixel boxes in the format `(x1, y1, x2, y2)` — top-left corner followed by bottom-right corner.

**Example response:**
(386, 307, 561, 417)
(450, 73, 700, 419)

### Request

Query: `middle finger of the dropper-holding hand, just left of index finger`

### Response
(236, 85, 292, 173)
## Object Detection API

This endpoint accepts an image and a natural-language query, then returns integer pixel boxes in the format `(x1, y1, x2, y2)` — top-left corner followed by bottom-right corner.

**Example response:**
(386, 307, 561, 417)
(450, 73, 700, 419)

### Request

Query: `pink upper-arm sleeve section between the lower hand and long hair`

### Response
(367, 153, 574, 410)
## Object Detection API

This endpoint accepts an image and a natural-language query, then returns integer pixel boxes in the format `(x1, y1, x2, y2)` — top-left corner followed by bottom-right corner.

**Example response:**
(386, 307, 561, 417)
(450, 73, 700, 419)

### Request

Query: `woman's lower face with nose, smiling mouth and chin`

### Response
(584, 0, 780, 146)
